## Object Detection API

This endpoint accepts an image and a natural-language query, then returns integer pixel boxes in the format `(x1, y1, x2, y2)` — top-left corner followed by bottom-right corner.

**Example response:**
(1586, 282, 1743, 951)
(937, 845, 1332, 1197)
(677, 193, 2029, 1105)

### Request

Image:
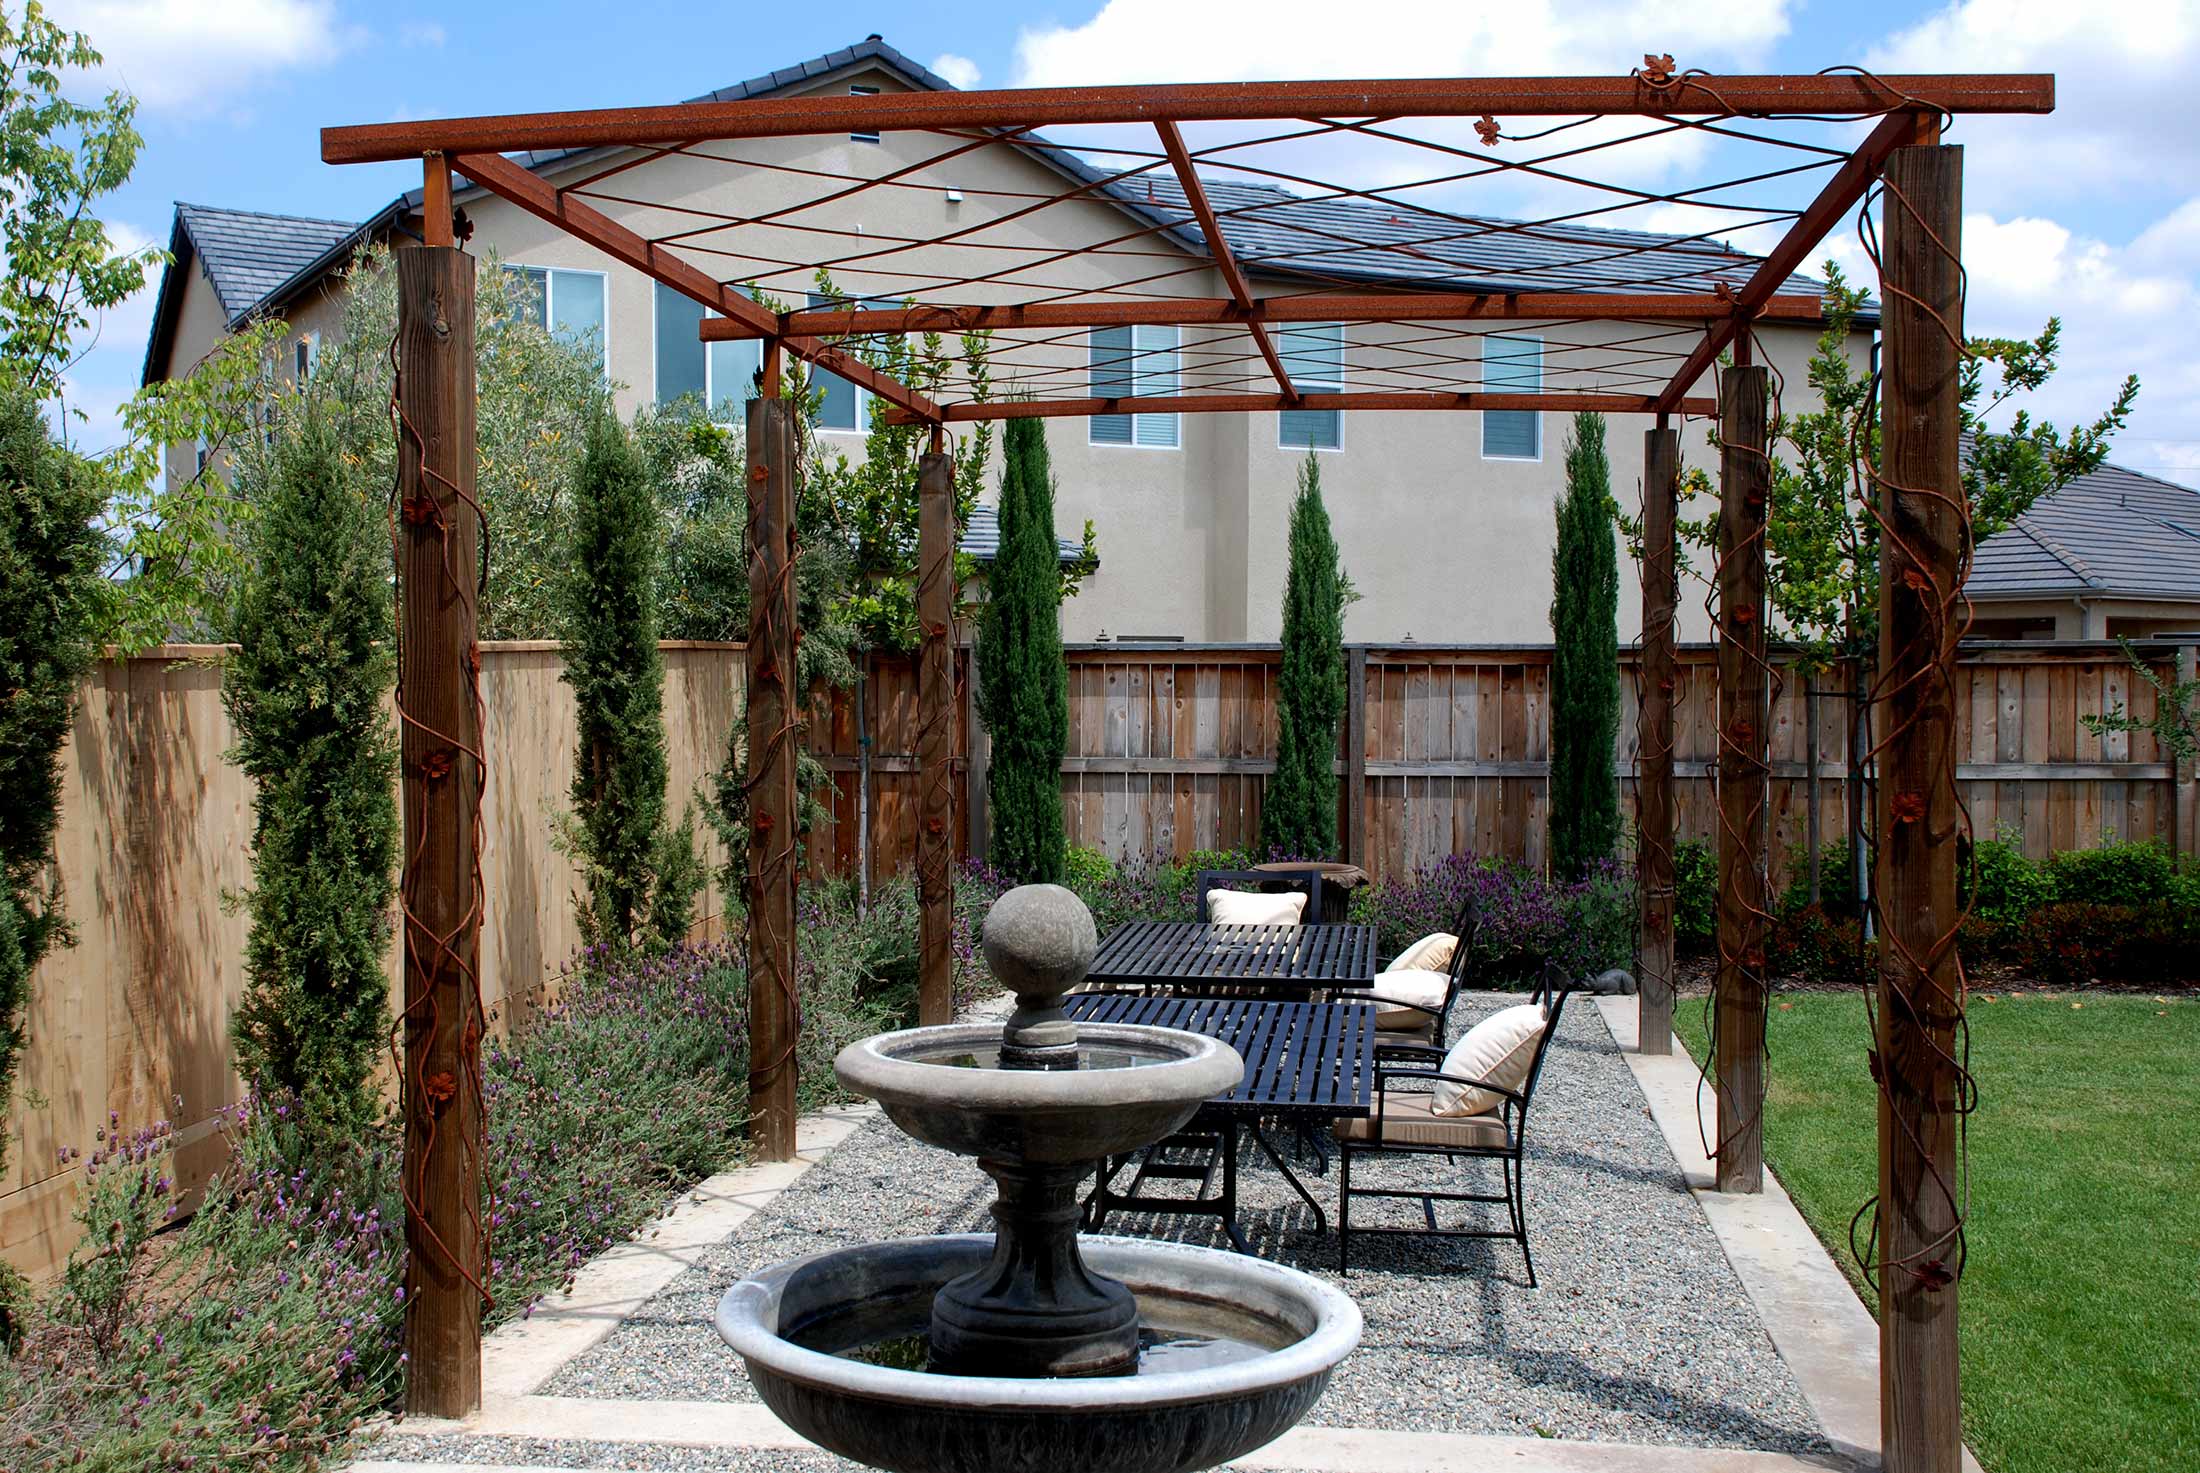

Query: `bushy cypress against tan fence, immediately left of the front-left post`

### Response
(222, 409, 398, 1130)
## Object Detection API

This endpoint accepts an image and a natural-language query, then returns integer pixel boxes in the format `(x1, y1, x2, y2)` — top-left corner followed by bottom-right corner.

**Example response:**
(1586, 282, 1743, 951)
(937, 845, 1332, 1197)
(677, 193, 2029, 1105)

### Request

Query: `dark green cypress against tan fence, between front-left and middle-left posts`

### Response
(563, 407, 678, 945)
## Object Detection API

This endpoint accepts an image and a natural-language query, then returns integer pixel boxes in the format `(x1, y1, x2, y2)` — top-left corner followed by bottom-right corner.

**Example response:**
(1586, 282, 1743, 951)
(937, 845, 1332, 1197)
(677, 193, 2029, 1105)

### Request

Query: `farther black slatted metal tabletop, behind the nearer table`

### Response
(1085, 921, 1375, 1000)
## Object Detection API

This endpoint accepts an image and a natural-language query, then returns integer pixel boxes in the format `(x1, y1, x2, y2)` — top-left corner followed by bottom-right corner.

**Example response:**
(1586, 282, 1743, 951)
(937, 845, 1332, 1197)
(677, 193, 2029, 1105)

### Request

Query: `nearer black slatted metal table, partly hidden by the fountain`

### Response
(1065, 992, 1377, 1253)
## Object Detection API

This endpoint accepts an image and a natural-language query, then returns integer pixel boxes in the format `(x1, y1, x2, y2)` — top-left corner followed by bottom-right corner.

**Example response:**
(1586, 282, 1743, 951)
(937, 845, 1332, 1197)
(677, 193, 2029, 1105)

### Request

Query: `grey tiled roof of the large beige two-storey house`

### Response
(145, 35, 1879, 383)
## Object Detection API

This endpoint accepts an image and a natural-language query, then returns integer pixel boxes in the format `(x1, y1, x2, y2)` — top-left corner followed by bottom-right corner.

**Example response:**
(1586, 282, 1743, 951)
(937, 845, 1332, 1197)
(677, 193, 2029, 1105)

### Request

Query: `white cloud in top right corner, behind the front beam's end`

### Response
(1866, 0, 2200, 211)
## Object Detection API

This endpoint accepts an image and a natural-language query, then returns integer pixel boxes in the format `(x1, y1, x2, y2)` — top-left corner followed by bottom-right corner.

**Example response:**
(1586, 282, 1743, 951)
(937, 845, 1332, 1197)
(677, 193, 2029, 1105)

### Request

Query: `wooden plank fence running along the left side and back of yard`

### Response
(0, 642, 2196, 1273)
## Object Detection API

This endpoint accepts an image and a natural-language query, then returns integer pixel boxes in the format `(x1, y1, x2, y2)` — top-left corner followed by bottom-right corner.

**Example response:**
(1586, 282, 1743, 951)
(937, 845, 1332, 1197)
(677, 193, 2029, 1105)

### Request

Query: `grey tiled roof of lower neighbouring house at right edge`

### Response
(1967, 452, 2200, 602)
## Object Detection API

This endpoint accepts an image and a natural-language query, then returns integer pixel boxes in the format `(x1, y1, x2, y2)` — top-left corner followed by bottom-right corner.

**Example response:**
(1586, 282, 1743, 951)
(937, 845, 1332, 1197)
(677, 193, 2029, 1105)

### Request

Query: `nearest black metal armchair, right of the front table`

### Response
(1335, 963, 1573, 1288)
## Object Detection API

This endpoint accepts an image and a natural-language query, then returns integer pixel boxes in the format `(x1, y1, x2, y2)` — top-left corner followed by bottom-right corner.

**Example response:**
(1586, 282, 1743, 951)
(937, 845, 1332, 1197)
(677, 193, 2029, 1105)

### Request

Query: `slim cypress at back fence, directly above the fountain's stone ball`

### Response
(977, 420, 1069, 884)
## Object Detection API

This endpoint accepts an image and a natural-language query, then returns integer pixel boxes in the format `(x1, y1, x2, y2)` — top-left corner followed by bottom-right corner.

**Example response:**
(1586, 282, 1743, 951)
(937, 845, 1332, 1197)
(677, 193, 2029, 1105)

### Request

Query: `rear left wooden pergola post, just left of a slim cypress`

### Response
(917, 429, 955, 1025)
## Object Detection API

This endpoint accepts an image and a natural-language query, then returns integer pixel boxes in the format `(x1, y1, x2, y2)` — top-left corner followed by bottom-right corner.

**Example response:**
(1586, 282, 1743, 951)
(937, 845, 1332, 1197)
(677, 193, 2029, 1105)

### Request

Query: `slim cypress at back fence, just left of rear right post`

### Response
(1551, 413, 1619, 879)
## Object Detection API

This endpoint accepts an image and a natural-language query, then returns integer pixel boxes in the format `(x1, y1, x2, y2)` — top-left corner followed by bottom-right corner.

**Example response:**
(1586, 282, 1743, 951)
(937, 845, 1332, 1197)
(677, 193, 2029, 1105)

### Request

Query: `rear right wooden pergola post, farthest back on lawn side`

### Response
(1635, 416, 1681, 1053)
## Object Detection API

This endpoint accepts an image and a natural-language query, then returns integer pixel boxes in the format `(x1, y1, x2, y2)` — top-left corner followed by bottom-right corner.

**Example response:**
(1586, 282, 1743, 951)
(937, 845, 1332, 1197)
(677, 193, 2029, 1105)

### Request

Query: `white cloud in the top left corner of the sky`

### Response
(53, 0, 361, 117)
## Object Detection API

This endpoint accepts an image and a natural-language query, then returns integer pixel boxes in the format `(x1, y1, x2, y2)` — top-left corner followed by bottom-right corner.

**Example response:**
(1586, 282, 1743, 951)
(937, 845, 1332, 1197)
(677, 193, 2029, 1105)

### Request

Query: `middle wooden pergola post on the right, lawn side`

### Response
(1714, 367, 1771, 1192)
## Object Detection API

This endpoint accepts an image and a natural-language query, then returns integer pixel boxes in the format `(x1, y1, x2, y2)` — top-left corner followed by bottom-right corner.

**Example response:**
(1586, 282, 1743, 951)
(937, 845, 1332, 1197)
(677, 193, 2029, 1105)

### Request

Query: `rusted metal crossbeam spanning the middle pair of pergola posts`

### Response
(702, 292, 1826, 343)
